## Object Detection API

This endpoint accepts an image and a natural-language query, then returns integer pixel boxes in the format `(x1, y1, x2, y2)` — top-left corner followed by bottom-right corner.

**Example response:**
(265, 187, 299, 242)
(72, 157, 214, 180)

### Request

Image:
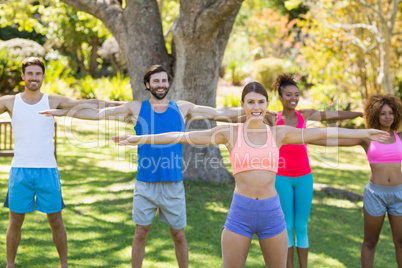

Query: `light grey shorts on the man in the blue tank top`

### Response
(133, 181, 187, 230)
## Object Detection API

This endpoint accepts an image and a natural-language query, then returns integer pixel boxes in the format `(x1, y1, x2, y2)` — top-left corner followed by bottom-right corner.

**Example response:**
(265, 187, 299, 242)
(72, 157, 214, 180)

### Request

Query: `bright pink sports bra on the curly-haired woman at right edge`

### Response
(367, 132, 402, 164)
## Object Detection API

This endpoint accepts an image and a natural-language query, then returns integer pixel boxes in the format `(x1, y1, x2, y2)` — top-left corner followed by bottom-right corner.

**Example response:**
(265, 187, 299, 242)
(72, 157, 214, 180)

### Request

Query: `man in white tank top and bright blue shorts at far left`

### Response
(0, 57, 119, 268)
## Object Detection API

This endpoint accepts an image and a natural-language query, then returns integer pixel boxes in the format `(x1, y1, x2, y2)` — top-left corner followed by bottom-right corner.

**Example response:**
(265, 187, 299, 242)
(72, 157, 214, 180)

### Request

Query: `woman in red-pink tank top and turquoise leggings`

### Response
(267, 74, 363, 268)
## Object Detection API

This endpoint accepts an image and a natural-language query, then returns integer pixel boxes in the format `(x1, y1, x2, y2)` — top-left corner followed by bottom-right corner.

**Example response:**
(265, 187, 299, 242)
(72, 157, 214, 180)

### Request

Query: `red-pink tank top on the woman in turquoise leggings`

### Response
(277, 110, 311, 177)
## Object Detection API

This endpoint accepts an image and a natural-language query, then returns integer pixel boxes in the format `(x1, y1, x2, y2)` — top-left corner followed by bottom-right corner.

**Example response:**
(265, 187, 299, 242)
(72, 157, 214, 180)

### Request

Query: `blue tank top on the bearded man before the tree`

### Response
(134, 100, 186, 182)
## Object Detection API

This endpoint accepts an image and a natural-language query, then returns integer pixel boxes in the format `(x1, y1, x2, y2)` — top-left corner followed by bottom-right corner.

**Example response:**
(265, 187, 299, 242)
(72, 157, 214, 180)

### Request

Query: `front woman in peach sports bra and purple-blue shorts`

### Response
(113, 82, 389, 268)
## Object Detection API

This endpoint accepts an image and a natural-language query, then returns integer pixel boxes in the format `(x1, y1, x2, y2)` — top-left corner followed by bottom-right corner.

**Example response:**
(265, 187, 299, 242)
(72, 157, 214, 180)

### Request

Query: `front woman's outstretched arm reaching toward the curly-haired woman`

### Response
(278, 126, 390, 146)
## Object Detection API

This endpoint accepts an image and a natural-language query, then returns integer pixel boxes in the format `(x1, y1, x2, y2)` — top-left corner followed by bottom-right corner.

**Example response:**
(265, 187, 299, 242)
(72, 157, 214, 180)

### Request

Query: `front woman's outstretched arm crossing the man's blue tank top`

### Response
(112, 126, 231, 145)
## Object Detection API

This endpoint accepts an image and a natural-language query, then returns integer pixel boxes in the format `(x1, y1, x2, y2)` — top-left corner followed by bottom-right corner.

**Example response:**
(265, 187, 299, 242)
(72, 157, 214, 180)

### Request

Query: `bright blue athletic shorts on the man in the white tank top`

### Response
(4, 167, 65, 214)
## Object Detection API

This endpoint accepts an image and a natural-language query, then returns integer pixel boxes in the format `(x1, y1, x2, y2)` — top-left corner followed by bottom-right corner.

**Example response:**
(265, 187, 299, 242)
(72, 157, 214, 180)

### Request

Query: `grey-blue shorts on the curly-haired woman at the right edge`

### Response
(363, 182, 402, 217)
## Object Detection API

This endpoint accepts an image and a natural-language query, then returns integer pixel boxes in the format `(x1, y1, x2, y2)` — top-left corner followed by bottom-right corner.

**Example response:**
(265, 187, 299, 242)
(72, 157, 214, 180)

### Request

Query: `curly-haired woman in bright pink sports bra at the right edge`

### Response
(309, 95, 402, 267)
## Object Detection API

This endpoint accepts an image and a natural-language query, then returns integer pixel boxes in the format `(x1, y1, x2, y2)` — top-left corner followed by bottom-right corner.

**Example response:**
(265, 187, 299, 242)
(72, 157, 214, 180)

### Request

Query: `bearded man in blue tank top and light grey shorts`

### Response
(43, 65, 245, 267)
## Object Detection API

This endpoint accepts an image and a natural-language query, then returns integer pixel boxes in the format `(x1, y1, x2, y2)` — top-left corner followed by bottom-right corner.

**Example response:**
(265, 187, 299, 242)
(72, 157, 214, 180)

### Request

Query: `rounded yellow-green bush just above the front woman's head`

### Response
(253, 58, 286, 90)
